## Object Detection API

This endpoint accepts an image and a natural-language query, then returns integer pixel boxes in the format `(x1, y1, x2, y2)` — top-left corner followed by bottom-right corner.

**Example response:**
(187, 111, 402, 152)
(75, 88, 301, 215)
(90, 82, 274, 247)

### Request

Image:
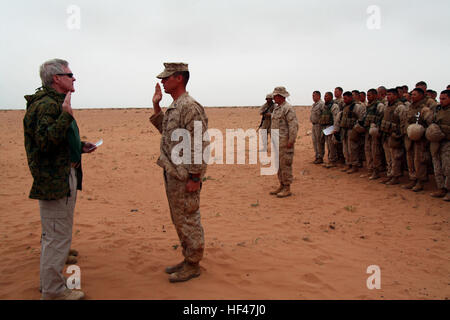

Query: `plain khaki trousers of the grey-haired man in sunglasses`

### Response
(39, 168, 77, 298)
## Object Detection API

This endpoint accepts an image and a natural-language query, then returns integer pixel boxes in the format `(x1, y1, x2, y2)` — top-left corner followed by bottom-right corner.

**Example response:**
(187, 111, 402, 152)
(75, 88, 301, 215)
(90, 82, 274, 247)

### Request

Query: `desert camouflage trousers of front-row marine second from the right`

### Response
(405, 137, 429, 181)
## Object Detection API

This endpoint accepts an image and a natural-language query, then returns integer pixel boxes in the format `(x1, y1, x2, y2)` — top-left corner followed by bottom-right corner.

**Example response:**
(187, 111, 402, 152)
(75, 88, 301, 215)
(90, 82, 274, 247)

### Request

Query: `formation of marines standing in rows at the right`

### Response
(310, 81, 450, 201)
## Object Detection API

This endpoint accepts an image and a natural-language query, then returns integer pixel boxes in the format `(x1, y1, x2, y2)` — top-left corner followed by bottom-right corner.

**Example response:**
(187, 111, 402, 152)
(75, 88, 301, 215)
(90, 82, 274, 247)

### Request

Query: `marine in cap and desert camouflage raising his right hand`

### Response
(150, 63, 208, 282)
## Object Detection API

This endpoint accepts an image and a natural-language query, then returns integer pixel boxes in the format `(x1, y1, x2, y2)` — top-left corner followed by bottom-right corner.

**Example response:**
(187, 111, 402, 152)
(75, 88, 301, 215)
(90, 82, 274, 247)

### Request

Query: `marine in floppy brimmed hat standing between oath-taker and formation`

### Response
(270, 87, 298, 198)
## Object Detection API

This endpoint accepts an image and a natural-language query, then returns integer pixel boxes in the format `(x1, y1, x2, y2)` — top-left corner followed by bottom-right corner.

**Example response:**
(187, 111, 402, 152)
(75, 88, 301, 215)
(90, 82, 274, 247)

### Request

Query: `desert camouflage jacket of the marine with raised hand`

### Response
(150, 92, 209, 181)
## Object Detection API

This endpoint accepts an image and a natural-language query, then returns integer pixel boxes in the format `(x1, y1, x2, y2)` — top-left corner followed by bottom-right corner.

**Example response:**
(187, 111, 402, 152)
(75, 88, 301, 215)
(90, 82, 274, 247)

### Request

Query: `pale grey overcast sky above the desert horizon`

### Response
(0, 0, 450, 109)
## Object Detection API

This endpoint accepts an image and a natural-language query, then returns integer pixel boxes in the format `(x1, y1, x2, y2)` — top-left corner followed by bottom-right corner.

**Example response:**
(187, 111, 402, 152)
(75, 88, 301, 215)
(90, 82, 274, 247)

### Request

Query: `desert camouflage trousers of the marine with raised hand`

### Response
(164, 172, 205, 263)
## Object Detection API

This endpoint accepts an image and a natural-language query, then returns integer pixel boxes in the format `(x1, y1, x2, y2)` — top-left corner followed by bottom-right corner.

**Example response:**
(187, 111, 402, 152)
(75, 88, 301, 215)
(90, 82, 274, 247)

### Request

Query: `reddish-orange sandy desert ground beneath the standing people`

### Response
(0, 107, 450, 300)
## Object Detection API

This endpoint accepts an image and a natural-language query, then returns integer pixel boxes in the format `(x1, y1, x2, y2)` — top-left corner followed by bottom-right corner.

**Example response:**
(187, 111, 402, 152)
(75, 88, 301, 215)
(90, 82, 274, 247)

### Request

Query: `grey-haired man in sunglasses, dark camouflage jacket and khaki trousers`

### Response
(23, 59, 96, 300)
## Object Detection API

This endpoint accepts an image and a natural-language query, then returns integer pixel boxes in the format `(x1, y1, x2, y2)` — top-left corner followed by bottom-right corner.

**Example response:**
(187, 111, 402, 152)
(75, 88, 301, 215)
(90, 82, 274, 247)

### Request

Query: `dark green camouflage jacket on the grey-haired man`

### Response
(23, 87, 74, 200)
